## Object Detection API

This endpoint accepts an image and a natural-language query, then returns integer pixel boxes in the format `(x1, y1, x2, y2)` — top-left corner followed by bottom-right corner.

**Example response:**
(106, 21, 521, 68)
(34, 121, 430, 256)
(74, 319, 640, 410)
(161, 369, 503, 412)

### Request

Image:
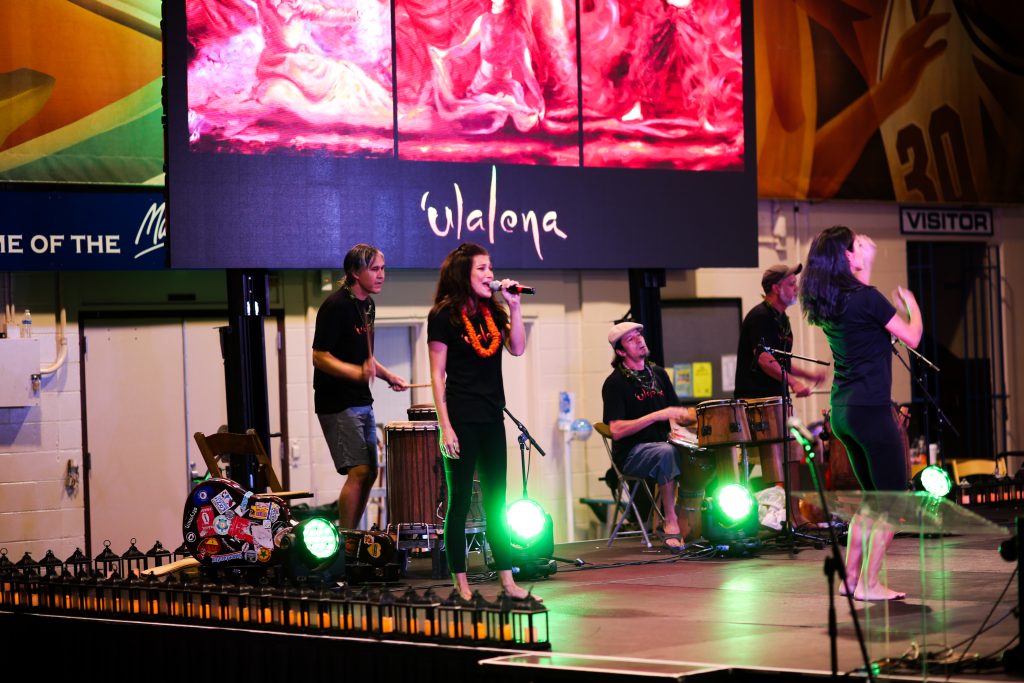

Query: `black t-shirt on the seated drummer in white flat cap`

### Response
(601, 365, 679, 467)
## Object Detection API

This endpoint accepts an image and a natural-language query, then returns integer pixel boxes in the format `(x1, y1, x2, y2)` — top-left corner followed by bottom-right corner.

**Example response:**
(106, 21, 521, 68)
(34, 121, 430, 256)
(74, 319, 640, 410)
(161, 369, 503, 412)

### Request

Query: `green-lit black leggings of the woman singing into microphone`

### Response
(444, 422, 512, 573)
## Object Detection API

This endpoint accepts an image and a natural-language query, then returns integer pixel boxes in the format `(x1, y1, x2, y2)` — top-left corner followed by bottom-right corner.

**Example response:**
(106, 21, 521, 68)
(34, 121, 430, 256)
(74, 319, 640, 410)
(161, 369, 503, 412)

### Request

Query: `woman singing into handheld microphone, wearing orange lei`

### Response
(427, 243, 527, 599)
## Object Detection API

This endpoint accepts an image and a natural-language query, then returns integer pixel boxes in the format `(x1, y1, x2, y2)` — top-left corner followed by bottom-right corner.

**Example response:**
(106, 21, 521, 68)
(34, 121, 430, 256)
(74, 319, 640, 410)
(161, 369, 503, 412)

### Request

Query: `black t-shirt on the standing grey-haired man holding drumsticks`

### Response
(313, 287, 374, 414)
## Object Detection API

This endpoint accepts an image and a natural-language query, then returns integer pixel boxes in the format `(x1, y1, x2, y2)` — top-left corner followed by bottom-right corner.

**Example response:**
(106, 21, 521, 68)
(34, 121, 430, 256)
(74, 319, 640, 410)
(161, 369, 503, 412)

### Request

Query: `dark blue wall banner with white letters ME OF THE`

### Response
(0, 188, 167, 270)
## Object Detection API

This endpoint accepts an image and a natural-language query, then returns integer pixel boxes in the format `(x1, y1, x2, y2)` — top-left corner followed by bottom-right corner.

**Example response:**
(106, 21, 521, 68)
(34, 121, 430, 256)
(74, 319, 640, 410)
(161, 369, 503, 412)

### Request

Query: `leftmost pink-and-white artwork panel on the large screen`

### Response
(187, 0, 394, 157)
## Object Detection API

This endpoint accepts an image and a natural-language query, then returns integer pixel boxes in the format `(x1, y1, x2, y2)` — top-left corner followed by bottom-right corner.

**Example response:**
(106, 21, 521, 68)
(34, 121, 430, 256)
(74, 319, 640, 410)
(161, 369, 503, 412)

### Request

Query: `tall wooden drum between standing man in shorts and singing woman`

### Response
(384, 420, 447, 524)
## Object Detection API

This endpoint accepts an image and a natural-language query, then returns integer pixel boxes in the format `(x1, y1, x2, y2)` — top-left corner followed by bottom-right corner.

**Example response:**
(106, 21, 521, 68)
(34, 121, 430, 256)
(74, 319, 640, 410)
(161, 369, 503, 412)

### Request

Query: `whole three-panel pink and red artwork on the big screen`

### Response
(187, 0, 743, 170)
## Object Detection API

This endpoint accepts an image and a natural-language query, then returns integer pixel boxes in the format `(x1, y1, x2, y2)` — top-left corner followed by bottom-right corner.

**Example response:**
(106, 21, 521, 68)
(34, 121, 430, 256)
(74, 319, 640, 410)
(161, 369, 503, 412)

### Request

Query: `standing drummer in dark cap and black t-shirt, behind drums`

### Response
(735, 263, 825, 483)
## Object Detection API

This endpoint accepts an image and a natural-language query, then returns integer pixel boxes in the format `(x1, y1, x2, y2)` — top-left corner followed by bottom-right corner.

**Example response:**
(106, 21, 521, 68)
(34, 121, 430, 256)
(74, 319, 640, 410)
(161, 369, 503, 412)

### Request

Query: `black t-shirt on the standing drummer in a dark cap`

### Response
(734, 301, 793, 398)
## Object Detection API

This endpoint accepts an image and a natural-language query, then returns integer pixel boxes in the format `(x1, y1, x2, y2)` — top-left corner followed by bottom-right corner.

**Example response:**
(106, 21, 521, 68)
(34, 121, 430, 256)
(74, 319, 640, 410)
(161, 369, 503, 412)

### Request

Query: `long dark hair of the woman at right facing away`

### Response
(800, 225, 864, 326)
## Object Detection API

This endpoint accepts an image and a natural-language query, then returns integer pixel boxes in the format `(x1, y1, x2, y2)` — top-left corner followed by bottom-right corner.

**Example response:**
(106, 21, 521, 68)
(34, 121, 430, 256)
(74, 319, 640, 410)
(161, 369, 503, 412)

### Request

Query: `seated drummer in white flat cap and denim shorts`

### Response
(601, 323, 696, 552)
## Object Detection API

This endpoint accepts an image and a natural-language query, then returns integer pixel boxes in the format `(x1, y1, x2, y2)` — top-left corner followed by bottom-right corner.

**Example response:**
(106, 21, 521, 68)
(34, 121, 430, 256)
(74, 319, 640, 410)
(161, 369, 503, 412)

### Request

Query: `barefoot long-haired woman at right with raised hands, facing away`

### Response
(800, 225, 923, 600)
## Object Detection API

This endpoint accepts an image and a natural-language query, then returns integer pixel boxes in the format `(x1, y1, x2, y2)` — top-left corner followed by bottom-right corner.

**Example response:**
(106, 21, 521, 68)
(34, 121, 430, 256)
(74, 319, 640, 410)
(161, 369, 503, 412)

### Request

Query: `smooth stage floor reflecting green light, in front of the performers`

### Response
(395, 518, 1019, 680)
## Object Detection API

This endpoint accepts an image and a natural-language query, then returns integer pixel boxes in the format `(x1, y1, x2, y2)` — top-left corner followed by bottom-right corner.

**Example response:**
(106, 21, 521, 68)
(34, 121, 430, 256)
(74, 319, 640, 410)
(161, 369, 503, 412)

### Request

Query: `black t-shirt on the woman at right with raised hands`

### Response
(821, 287, 896, 405)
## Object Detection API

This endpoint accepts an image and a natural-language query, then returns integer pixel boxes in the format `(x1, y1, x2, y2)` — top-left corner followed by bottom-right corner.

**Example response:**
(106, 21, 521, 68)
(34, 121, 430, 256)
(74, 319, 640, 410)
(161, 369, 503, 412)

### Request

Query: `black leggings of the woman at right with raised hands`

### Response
(831, 405, 910, 490)
